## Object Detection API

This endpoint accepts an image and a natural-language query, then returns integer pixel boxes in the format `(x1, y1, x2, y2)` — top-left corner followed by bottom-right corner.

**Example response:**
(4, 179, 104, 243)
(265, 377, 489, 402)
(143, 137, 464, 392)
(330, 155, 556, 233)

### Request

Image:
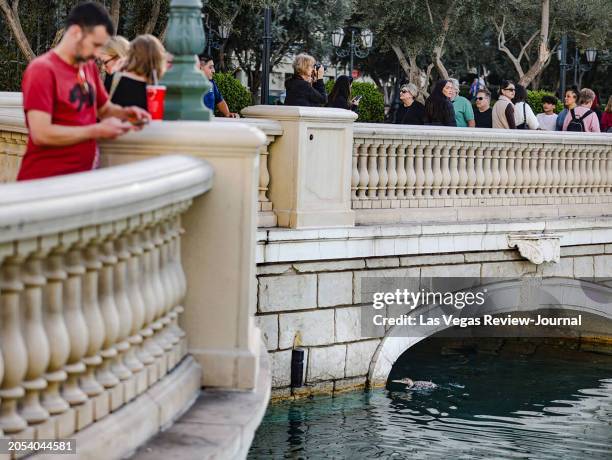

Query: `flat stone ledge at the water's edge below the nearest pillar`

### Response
(131, 342, 271, 460)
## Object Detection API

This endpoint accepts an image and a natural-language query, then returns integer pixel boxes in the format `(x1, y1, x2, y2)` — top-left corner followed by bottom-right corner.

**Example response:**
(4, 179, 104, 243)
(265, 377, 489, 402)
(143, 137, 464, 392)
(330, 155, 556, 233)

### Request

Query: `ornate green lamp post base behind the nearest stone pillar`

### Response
(161, 0, 214, 121)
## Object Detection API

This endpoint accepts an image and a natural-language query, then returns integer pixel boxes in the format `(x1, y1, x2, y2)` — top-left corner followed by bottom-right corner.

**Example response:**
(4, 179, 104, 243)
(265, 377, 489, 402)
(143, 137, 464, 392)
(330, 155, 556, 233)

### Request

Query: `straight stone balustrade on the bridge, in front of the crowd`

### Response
(351, 124, 612, 223)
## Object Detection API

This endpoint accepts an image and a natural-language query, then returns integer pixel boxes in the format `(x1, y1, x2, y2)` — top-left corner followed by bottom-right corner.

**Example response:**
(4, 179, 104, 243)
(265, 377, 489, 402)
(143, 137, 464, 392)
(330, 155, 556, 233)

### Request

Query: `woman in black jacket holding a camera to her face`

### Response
(285, 53, 327, 107)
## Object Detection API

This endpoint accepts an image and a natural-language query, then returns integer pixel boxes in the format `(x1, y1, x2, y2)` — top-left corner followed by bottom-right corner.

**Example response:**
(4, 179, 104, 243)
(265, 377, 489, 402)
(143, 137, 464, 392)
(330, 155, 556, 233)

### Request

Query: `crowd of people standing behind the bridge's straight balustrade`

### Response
(285, 54, 612, 133)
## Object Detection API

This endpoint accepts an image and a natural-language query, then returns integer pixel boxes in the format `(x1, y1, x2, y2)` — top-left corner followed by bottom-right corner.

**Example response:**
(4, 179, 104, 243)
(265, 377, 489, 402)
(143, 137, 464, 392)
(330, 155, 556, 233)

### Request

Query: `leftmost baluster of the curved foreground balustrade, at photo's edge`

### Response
(0, 251, 28, 435)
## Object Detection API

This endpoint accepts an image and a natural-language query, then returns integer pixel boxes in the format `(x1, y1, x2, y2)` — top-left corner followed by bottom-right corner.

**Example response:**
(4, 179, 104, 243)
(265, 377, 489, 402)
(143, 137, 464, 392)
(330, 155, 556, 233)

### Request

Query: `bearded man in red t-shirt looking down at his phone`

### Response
(17, 2, 150, 180)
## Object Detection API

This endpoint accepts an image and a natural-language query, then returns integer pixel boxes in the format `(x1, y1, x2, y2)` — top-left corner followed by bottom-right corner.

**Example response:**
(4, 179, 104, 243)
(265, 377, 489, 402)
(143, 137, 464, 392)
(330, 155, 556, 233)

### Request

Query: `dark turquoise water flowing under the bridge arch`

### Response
(249, 340, 612, 460)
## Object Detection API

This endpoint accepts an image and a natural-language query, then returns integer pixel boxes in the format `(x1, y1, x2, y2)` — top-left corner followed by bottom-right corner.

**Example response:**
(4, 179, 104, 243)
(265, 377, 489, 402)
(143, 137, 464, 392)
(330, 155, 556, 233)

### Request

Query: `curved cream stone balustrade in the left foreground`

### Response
(0, 156, 213, 450)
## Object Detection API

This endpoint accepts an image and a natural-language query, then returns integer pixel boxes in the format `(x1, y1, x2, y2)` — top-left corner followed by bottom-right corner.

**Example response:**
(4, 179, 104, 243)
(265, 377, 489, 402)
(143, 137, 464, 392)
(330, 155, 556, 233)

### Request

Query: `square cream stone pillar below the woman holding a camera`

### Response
(242, 105, 357, 228)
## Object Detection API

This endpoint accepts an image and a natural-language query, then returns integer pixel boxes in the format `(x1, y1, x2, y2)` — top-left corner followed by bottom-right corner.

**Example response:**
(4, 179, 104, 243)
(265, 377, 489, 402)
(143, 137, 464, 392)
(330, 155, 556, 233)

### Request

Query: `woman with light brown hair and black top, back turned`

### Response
(109, 34, 166, 110)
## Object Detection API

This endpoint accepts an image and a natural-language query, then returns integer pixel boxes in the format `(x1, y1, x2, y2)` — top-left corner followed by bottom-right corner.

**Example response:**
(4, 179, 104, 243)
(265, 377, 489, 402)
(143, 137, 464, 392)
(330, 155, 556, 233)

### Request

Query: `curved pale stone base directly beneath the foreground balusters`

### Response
(32, 356, 202, 460)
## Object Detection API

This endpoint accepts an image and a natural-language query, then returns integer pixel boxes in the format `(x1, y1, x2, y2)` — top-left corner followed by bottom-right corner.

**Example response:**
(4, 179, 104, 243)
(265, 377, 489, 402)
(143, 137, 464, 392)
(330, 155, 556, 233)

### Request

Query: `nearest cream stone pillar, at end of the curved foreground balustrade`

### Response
(101, 121, 266, 389)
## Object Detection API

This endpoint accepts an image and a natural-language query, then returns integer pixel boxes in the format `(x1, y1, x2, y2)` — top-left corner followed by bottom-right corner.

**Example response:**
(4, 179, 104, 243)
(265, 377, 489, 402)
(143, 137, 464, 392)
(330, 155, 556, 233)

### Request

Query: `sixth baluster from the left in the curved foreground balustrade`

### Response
(98, 228, 123, 388)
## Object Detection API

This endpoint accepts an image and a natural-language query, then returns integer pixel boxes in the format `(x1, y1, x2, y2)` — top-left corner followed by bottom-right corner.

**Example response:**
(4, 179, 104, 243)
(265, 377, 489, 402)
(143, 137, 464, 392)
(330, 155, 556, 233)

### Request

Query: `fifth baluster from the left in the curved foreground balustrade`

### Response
(81, 234, 106, 398)
